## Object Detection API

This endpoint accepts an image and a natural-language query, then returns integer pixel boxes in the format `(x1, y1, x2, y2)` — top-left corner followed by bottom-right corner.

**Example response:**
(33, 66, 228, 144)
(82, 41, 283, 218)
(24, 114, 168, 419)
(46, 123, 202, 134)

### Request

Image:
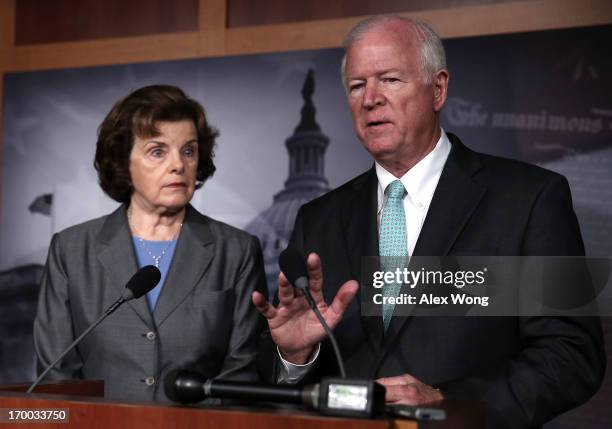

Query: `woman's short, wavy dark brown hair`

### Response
(94, 85, 219, 203)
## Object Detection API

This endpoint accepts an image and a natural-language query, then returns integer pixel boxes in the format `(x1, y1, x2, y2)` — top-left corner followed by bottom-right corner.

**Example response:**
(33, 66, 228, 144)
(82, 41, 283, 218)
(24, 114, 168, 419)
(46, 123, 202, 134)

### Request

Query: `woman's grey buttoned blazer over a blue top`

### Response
(34, 206, 267, 401)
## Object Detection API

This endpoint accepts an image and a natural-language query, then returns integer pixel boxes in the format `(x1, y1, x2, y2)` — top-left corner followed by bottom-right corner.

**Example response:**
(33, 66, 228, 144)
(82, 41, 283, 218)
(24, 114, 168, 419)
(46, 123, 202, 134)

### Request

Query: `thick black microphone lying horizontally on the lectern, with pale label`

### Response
(164, 368, 385, 417)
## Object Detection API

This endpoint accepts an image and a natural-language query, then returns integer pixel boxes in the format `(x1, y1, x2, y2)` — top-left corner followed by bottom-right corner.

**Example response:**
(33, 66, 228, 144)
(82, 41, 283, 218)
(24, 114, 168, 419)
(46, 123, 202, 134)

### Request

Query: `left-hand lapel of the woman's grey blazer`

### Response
(97, 205, 153, 327)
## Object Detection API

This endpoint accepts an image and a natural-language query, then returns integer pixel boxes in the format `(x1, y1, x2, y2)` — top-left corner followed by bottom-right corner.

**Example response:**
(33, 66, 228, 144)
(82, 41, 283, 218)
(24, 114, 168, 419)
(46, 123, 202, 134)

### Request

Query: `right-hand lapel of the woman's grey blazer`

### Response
(153, 205, 215, 327)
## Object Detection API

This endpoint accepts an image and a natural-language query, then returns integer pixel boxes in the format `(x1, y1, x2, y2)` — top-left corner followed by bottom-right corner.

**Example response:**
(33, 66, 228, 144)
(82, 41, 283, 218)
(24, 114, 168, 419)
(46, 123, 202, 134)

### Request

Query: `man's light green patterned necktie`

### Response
(378, 180, 408, 332)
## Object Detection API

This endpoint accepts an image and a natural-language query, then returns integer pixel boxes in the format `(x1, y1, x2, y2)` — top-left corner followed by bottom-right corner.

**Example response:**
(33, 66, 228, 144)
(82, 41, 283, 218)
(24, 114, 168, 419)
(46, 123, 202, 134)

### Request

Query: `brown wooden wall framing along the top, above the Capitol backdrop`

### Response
(0, 0, 612, 73)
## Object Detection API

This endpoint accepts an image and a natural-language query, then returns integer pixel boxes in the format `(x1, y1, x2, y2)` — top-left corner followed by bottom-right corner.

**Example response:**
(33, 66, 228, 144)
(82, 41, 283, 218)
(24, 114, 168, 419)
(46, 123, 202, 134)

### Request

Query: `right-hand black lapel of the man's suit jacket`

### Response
(379, 134, 486, 358)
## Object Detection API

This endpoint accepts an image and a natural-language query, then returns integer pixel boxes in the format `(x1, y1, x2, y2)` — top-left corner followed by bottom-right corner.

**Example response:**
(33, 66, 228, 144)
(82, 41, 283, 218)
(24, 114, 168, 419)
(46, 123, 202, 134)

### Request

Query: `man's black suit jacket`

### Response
(261, 134, 605, 427)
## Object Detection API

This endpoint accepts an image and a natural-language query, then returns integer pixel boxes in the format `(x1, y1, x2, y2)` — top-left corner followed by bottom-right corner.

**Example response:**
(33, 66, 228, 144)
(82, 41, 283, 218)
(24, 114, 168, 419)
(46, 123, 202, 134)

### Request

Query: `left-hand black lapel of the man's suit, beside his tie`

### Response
(342, 168, 383, 351)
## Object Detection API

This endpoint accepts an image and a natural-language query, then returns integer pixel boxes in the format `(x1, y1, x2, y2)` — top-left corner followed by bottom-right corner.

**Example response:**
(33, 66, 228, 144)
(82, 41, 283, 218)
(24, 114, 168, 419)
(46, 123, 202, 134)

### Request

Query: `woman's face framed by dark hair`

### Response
(130, 120, 198, 213)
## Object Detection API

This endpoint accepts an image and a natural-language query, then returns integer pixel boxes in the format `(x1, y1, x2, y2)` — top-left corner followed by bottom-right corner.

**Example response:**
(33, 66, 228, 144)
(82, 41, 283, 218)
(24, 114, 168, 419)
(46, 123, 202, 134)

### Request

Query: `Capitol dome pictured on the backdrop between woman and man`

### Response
(245, 69, 329, 296)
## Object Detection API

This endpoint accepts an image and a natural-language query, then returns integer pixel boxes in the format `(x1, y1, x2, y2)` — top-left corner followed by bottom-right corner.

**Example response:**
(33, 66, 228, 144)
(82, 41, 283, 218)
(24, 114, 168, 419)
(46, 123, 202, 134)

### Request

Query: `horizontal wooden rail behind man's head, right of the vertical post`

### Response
(227, 0, 612, 55)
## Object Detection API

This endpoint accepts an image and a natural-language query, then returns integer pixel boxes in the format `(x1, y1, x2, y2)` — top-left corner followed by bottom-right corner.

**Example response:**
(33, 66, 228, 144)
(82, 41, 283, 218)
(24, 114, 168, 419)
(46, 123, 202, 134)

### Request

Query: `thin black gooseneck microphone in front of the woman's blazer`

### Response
(26, 265, 161, 393)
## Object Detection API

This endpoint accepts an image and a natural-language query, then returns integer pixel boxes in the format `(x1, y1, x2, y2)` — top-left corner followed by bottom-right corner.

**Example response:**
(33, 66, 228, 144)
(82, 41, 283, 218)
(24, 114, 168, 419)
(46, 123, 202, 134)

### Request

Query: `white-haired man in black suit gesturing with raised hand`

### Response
(253, 16, 605, 427)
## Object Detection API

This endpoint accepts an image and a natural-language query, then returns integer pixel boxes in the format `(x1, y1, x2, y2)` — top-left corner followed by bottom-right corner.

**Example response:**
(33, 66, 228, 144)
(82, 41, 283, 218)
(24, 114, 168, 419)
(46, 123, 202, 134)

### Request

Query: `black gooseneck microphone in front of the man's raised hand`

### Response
(278, 247, 346, 378)
